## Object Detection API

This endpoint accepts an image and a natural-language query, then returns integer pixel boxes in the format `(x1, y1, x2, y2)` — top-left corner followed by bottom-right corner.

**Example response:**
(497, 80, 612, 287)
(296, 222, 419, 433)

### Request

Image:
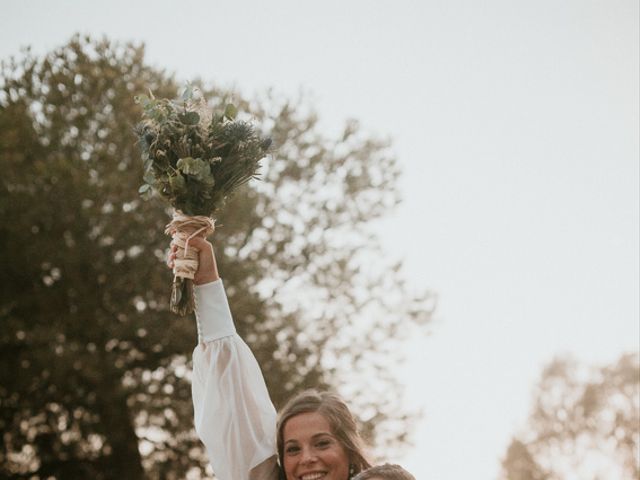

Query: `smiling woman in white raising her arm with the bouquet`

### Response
(168, 237, 370, 480)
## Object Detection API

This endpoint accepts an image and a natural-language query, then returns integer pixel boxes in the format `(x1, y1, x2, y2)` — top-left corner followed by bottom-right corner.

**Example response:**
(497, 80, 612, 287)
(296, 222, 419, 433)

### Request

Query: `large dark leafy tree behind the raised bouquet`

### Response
(0, 36, 433, 479)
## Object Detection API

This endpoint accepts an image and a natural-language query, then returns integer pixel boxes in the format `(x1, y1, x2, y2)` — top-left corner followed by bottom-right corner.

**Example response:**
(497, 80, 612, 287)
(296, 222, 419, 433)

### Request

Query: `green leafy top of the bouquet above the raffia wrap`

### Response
(136, 85, 270, 216)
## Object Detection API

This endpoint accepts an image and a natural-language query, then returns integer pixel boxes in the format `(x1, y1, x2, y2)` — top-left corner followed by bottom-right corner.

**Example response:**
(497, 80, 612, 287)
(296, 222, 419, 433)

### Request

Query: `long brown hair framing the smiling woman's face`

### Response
(277, 390, 371, 473)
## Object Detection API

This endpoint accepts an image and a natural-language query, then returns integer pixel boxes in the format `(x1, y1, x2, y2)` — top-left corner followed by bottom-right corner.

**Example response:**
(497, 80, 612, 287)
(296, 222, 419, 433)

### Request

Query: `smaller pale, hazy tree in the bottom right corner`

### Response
(503, 354, 640, 480)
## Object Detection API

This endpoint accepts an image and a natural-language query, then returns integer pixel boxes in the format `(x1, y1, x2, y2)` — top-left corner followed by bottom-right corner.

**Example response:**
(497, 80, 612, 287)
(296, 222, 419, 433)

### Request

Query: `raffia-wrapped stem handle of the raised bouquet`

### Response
(164, 211, 215, 315)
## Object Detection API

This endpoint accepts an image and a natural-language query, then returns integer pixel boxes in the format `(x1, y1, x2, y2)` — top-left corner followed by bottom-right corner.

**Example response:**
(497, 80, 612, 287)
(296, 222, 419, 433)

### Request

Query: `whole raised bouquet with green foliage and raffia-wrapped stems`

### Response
(135, 86, 271, 315)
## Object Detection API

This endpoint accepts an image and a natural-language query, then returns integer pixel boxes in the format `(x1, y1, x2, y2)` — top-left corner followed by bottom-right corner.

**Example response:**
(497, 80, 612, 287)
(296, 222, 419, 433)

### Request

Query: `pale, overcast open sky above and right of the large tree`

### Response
(0, 0, 640, 480)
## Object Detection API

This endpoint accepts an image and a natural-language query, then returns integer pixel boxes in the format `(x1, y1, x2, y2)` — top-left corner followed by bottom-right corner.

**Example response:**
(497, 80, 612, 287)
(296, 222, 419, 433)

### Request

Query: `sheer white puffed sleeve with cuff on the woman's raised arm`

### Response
(192, 280, 278, 480)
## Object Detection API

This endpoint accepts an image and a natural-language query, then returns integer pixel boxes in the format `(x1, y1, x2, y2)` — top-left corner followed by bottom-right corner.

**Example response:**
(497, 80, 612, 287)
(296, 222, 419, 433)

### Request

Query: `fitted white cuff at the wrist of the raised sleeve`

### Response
(195, 279, 236, 342)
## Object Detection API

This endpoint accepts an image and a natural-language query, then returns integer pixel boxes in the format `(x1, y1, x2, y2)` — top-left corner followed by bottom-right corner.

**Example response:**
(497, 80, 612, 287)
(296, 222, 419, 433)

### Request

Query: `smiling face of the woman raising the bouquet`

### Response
(283, 412, 349, 480)
